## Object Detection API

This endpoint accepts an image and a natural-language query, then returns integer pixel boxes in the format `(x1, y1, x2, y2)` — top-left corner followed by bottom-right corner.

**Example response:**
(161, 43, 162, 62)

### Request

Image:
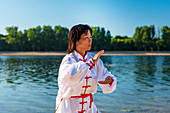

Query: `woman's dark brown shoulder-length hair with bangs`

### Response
(67, 24, 92, 54)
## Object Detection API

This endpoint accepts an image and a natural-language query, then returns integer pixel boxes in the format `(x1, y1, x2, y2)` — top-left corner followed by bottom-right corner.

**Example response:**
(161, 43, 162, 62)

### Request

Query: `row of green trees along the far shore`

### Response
(0, 25, 170, 51)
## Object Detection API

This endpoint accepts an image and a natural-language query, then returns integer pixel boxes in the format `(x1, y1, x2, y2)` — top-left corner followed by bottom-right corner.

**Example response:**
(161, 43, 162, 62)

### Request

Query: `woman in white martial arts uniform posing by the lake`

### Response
(55, 24, 117, 113)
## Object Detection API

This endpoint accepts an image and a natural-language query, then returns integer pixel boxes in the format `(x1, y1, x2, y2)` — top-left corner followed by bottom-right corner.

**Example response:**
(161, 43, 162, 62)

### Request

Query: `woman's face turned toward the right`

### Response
(76, 30, 92, 51)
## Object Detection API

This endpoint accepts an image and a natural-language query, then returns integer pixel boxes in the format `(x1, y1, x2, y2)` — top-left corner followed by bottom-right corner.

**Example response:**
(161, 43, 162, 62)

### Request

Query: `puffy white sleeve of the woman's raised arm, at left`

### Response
(58, 57, 91, 86)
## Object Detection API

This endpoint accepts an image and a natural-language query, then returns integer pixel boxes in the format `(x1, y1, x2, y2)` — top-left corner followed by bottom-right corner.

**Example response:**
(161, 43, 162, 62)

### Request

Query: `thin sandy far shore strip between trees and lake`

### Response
(0, 51, 170, 56)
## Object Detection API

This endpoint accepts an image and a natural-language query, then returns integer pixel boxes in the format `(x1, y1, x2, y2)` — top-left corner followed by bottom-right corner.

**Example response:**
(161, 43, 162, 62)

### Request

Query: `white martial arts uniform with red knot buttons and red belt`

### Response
(55, 50, 117, 113)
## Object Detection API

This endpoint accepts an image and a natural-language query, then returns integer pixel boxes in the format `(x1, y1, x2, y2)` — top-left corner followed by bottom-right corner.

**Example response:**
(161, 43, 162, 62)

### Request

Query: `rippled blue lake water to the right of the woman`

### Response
(97, 56, 170, 112)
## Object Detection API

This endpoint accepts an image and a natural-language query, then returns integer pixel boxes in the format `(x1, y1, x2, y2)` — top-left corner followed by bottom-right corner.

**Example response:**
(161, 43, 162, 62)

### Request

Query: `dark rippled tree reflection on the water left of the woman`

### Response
(0, 57, 62, 91)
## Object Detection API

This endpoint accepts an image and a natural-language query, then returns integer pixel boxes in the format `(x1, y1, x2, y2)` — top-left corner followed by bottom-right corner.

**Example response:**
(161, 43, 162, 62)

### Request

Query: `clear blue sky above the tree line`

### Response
(0, 0, 170, 37)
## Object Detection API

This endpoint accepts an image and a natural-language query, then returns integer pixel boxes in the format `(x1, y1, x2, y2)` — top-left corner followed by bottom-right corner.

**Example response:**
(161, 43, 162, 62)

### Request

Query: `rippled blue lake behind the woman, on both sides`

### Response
(0, 56, 170, 113)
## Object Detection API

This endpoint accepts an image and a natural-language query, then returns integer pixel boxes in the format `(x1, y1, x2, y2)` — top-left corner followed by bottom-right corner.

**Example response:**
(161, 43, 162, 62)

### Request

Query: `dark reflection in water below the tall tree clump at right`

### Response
(134, 56, 157, 92)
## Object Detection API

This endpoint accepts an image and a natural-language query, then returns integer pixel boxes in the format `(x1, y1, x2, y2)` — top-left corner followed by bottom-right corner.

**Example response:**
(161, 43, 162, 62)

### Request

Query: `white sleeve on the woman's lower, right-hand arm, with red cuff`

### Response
(97, 59, 117, 93)
